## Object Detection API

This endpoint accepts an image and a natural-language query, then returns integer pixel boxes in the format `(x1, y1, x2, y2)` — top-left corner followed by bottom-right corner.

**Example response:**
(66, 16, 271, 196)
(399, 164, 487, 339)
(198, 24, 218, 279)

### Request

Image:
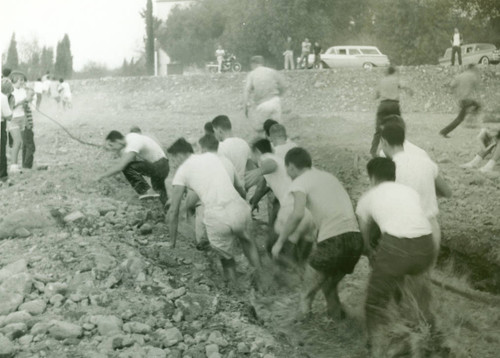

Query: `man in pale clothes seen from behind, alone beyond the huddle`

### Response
(243, 56, 286, 136)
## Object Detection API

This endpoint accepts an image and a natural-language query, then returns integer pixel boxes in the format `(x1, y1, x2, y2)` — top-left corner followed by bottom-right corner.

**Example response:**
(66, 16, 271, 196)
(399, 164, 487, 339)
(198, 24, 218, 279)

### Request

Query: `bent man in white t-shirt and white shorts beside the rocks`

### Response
(167, 138, 260, 284)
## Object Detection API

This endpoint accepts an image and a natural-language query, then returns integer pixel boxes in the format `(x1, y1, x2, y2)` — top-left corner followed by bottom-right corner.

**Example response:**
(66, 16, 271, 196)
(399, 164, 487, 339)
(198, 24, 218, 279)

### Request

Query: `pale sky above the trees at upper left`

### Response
(0, 0, 146, 71)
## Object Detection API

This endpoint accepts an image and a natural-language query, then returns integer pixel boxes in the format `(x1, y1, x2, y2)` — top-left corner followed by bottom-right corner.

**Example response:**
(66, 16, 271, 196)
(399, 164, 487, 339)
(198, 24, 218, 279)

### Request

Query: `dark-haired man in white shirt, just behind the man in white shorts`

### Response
(212, 115, 253, 187)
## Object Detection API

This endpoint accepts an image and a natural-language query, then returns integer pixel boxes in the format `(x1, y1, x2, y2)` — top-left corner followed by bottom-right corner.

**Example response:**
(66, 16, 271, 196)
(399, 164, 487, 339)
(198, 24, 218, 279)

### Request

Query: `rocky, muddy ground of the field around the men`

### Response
(0, 67, 500, 358)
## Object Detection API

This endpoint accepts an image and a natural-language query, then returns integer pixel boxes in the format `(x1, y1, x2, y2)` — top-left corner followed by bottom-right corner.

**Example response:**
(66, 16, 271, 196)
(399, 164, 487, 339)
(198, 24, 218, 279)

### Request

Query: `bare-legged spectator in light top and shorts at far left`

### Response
(9, 72, 27, 173)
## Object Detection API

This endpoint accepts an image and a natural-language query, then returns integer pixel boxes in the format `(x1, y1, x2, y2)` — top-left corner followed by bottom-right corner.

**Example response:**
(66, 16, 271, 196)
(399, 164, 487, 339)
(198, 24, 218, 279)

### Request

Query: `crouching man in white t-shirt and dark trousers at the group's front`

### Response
(97, 130, 170, 204)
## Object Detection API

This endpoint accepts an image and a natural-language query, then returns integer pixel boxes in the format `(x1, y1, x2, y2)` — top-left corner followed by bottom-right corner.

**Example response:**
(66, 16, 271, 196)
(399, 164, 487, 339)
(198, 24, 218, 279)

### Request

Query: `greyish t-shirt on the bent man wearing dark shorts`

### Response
(290, 168, 359, 242)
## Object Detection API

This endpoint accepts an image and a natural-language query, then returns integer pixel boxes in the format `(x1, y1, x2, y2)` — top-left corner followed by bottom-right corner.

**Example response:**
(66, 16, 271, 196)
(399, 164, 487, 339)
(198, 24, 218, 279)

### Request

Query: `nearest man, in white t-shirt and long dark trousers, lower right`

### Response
(356, 158, 437, 357)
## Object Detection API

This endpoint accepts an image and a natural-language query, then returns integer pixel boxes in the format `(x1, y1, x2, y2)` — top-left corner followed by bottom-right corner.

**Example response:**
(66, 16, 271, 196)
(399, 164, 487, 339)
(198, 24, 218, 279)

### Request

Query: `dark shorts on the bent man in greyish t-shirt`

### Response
(309, 232, 363, 274)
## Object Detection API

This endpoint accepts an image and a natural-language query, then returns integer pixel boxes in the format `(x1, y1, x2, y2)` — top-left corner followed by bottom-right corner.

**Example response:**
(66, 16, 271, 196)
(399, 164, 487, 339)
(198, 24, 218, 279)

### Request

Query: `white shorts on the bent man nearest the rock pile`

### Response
(204, 199, 252, 259)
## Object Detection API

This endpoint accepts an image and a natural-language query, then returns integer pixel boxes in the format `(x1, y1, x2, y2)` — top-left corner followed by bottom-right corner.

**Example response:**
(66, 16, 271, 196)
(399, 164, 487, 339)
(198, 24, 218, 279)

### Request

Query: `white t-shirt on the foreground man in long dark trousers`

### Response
(356, 182, 432, 239)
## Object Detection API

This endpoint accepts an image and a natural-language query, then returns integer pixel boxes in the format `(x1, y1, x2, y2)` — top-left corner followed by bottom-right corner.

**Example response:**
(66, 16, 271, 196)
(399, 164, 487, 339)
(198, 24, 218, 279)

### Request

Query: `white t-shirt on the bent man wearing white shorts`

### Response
(172, 153, 241, 208)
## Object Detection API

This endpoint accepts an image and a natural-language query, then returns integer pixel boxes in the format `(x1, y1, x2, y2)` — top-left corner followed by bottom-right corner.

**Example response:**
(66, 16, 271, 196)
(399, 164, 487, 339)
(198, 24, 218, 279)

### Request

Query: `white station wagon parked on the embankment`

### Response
(309, 46, 390, 69)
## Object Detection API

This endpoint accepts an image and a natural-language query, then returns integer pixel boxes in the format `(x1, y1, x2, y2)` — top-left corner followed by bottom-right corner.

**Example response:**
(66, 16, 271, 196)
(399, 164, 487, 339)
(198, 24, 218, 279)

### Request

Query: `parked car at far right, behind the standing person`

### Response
(439, 44, 500, 66)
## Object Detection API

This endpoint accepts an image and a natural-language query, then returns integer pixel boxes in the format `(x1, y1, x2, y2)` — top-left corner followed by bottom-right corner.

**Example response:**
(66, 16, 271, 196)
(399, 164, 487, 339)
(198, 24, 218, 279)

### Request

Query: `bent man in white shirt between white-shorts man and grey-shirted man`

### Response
(245, 139, 316, 263)
